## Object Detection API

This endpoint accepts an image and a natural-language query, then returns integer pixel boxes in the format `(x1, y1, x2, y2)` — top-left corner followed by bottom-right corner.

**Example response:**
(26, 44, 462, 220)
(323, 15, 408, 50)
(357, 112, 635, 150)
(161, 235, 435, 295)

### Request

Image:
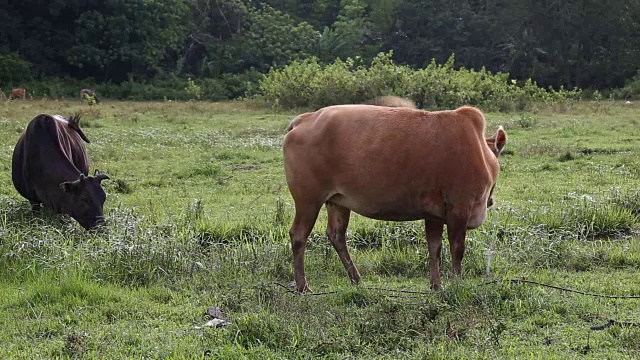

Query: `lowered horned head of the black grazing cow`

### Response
(60, 170, 109, 230)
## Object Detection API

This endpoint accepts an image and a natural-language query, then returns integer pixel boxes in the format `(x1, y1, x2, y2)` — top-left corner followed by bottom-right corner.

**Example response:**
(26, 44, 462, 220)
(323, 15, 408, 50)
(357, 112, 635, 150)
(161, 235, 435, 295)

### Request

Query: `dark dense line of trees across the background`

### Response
(0, 0, 640, 93)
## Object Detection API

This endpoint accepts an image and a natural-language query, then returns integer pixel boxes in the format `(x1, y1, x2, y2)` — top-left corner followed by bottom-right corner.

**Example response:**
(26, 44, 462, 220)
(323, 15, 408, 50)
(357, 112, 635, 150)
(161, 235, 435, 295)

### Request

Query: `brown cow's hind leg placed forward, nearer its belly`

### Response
(327, 202, 360, 284)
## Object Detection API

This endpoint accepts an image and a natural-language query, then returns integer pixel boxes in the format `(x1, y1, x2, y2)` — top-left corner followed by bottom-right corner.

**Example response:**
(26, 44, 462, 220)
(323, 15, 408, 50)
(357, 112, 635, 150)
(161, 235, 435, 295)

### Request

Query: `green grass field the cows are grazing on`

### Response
(0, 101, 640, 359)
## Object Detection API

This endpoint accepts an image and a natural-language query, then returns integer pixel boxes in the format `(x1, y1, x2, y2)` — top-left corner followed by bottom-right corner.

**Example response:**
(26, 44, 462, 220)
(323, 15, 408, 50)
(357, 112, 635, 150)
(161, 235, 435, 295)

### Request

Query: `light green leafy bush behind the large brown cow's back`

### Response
(259, 52, 580, 110)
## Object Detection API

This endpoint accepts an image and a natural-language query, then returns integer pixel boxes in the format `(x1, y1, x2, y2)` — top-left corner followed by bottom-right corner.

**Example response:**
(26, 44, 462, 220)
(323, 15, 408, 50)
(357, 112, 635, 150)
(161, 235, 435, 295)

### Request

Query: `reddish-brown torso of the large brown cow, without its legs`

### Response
(283, 105, 498, 220)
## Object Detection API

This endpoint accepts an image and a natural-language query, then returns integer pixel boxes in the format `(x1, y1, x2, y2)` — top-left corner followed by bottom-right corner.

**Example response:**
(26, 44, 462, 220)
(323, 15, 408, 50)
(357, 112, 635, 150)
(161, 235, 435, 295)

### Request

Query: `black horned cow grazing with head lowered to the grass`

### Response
(11, 114, 109, 230)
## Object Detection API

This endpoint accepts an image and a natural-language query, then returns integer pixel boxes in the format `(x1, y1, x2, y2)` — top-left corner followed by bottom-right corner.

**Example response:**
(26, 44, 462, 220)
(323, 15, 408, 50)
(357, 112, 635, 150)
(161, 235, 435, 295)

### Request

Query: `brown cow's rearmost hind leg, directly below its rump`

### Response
(289, 203, 322, 292)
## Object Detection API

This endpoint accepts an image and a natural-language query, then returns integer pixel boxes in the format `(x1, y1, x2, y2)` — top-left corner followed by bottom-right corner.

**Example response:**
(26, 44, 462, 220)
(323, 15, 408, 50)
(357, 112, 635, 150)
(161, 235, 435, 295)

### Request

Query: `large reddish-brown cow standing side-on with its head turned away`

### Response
(283, 105, 506, 292)
